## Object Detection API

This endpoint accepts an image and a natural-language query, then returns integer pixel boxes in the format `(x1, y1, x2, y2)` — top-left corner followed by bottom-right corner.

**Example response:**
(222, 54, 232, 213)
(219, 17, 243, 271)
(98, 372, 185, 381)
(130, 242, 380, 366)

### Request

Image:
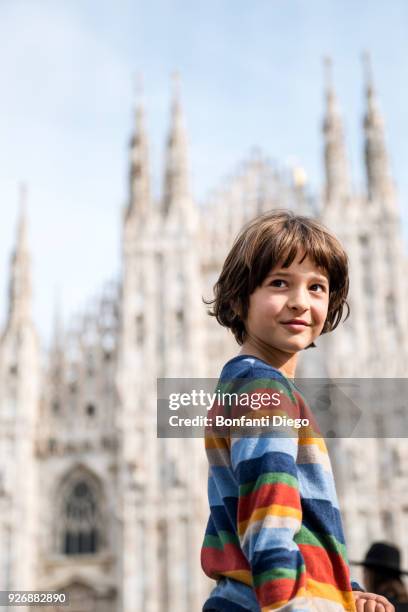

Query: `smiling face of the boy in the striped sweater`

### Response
(245, 253, 329, 353)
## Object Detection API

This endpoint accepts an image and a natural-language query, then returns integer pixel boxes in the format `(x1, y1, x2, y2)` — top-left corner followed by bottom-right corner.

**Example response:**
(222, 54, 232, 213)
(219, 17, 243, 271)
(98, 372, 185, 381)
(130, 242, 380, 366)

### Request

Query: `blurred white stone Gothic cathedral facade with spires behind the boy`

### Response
(0, 61, 408, 612)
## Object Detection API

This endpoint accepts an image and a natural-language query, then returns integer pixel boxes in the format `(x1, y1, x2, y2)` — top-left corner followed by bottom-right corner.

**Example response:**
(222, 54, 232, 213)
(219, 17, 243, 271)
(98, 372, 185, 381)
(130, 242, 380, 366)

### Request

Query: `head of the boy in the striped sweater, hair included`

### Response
(207, 210, 349, 353)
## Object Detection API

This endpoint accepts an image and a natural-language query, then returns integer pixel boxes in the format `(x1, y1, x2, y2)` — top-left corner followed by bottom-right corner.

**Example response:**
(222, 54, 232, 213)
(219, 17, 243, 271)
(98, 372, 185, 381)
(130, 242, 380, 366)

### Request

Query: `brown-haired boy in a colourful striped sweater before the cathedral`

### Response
(201, 210, 394, 612)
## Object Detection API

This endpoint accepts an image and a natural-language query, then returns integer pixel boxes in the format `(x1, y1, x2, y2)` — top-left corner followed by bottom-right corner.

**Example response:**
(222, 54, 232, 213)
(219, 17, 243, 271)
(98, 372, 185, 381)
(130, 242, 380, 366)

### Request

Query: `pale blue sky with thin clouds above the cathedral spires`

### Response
(0, 0, 408, 345)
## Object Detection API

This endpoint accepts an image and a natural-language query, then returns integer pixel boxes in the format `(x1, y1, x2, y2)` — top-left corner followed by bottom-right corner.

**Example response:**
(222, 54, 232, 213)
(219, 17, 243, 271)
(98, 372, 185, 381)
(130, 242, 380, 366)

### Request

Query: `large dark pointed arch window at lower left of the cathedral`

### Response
(59, 476, 102, 555)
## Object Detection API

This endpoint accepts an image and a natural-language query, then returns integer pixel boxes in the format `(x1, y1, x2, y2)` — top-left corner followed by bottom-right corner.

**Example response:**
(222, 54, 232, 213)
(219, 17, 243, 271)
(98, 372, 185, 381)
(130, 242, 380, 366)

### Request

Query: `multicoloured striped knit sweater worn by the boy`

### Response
(201, 355, 356, 612)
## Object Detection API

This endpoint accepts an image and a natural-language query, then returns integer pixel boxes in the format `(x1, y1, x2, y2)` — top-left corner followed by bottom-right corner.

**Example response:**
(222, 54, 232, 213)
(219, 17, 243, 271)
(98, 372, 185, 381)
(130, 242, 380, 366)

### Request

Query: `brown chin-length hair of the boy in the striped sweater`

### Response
(204, 210, 350, 348)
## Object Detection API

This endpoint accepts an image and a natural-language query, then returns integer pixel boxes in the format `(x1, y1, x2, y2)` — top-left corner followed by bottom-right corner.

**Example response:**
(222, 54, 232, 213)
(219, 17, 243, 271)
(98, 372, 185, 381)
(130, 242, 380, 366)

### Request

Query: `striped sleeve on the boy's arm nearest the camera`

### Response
(231, 371, 310, 612)
